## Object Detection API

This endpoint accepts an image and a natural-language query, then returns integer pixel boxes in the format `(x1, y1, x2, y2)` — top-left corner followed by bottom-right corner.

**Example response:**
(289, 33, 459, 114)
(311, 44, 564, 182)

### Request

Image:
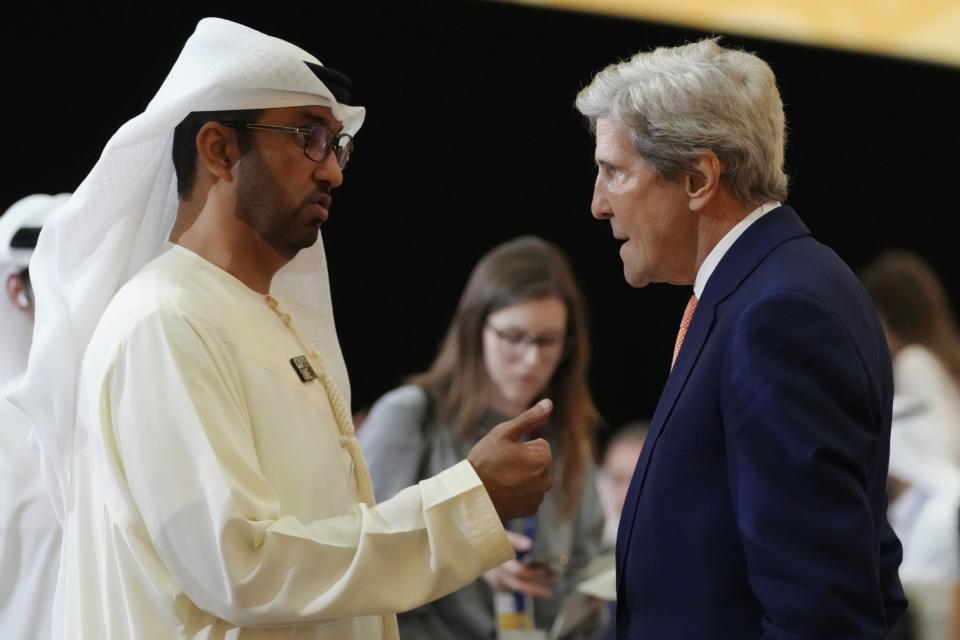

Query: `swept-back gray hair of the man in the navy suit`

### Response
(576, 38, 787, 204)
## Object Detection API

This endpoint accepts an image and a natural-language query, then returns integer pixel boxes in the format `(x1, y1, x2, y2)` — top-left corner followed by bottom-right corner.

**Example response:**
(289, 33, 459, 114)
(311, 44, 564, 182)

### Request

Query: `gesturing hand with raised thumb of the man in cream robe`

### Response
(467, 400, 553, 519)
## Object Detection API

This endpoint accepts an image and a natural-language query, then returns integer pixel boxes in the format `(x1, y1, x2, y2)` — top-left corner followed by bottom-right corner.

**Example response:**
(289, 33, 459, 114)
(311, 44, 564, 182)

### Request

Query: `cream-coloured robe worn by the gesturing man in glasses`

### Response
(63, 246, 513, 640)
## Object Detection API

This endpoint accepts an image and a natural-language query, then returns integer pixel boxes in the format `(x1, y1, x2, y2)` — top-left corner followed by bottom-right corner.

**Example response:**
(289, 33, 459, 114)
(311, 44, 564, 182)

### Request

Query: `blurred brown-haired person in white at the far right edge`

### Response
(861, 250, 960, 640)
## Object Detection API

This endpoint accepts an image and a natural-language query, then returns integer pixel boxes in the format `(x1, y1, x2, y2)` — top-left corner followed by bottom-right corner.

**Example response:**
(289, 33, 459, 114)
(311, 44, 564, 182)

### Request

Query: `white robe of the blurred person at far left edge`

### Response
(0, 378, 61, 640)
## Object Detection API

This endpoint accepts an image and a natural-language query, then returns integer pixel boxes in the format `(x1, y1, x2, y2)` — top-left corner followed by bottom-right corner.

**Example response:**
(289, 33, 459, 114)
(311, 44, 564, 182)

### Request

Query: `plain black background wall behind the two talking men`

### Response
(0, 1, 960, 448)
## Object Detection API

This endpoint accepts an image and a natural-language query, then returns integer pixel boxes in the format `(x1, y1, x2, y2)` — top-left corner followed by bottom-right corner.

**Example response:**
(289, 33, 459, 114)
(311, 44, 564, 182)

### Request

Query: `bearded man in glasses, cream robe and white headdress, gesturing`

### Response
(19, 19, 550, 640)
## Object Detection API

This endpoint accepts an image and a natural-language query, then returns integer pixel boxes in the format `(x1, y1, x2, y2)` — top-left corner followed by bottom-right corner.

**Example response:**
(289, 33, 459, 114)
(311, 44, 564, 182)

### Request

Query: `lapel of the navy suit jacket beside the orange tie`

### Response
(617, 207, 810, 596)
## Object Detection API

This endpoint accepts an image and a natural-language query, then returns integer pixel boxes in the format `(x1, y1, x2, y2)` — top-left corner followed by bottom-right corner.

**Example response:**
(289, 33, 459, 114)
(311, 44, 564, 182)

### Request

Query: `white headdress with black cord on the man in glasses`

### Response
(13, 18, 365, 522)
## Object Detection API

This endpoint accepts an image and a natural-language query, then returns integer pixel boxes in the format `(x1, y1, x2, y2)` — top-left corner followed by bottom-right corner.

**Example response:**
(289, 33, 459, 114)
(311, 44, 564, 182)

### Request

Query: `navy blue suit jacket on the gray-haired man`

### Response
(617, 207, 906, 640)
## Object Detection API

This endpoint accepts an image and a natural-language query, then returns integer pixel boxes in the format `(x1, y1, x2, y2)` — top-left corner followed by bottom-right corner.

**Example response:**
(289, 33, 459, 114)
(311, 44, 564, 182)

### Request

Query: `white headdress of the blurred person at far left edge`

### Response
(0, 193, 70, 387)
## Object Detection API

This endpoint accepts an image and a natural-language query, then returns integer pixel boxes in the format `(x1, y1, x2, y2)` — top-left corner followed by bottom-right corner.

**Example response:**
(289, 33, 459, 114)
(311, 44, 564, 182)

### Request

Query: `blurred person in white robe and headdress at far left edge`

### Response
(0, 193, 68, 640)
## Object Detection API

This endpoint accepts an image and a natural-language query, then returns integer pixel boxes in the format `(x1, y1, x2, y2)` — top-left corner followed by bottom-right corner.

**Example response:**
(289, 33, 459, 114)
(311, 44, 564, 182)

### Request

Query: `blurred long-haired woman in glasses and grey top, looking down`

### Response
(358, 237, 603, 640)
